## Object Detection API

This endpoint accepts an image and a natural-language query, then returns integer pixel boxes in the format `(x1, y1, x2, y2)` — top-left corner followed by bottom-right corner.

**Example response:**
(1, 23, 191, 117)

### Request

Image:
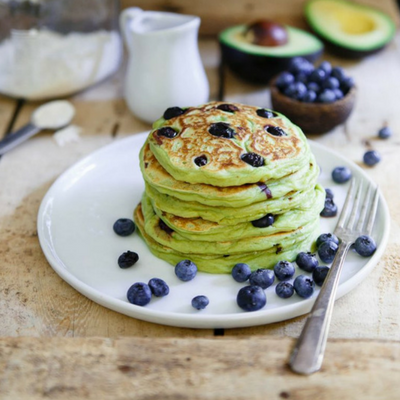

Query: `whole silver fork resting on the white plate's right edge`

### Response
(289, 178, 379, 375)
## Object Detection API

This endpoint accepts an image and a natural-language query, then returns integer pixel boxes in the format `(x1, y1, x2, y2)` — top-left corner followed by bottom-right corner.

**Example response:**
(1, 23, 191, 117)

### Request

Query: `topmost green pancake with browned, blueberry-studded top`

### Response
(148, 102, 310, 187)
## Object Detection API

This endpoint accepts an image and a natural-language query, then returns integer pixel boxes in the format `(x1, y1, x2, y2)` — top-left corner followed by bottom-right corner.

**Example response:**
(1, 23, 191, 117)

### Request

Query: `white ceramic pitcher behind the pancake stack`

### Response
(120, 7, 209, 123)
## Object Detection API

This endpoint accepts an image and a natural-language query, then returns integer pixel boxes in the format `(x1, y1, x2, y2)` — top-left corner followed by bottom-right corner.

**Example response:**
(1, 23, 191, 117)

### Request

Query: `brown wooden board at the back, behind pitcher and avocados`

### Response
(121, 0, 399, 35)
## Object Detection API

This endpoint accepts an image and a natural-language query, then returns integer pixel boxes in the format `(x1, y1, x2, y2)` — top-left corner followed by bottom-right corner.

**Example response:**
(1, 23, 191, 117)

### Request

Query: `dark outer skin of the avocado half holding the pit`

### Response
(220, 42, 323, 84)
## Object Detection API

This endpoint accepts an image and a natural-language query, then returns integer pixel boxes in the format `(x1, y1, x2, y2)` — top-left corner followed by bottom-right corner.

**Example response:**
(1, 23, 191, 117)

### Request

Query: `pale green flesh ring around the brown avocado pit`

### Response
(219, 25, 323, 57)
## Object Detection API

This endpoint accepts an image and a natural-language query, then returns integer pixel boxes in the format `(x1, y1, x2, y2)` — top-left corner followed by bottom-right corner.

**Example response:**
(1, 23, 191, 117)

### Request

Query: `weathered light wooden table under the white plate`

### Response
(0, 36, 400, 399)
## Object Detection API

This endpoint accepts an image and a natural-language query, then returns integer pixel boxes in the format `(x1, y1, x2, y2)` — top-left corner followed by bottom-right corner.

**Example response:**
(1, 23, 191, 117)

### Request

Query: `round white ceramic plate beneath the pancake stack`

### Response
(38, 133, 389, 328)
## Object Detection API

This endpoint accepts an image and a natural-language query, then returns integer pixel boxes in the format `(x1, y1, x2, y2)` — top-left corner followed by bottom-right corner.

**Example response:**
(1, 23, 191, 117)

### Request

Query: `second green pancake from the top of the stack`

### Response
(139, 143, 319, 207)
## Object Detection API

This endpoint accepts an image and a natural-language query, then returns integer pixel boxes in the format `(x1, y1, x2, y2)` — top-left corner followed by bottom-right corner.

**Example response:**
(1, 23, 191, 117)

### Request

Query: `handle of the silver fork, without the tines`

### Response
(289, 241, 351, 375)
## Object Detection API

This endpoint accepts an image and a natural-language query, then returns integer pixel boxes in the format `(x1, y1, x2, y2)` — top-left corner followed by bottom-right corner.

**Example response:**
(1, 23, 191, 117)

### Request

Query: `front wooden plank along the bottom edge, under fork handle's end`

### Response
(0, 336, 400, 400)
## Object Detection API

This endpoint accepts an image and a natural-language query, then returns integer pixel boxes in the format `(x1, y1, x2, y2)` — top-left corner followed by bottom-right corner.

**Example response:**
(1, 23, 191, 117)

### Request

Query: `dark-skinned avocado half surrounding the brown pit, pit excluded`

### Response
(219, 25, 324, 83)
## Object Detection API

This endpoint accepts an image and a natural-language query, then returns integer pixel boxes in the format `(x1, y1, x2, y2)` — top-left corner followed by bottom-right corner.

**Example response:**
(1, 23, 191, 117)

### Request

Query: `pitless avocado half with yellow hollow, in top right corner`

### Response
(304, 0, 396, 57)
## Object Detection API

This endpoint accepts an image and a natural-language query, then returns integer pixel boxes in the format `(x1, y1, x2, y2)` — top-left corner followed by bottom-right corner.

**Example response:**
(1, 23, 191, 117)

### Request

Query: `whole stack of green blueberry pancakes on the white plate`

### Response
(134, 102, 325, 273)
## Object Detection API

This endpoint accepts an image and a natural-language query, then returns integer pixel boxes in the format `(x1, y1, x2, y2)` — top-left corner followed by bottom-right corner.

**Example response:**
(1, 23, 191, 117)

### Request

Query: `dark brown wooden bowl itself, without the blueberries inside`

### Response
(271, 79, 357, 134)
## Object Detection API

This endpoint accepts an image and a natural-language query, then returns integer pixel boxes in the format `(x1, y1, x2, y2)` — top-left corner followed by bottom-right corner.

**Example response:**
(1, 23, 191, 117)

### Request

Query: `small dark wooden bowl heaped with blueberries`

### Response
(271, 57, 356, 134)
